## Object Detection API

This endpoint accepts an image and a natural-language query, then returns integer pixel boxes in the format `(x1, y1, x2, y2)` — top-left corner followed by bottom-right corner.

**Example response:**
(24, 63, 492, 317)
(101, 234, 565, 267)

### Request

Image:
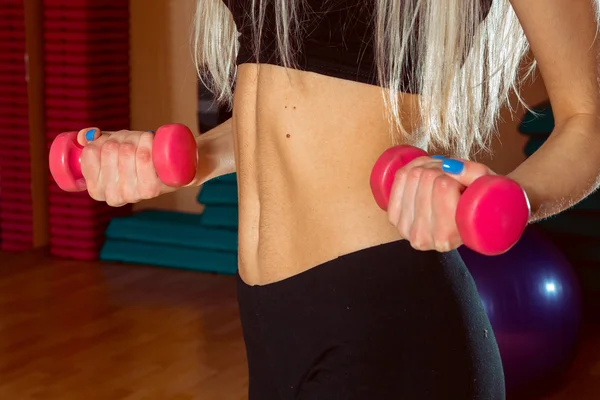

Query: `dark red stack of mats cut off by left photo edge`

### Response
(0, 0, 33, 251)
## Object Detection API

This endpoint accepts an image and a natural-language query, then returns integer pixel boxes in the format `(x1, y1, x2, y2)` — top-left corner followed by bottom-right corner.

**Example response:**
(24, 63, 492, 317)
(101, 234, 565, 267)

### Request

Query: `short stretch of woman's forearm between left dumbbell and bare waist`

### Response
(194, 118, 236, 185)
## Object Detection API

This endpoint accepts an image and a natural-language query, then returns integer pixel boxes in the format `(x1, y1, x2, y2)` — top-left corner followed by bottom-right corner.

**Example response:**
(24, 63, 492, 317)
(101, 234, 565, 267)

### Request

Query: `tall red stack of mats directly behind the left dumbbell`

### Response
(43, 0, 130, 259)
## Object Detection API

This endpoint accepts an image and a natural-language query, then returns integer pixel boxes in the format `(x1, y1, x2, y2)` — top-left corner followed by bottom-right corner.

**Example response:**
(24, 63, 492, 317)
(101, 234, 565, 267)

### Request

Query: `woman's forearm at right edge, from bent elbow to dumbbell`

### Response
(508, 114, 600, 222)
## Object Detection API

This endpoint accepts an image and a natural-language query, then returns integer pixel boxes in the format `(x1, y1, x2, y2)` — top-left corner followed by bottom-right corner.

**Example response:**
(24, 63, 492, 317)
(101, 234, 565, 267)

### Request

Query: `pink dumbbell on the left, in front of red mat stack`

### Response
(49, 124, 198, 192)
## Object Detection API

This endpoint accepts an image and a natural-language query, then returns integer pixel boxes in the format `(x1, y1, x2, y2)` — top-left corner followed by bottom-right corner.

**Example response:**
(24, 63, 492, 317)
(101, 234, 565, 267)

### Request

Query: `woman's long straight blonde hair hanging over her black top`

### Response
(193, 0, 534, 158)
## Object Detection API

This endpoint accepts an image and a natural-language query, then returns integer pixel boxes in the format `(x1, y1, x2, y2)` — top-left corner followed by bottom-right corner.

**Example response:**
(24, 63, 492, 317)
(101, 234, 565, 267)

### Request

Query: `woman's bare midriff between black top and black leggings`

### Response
(233, 64, 417, 284)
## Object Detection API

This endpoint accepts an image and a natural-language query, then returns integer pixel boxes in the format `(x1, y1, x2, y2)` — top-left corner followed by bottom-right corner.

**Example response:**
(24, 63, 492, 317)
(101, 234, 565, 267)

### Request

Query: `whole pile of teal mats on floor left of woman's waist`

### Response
(101, 174, 238, 275)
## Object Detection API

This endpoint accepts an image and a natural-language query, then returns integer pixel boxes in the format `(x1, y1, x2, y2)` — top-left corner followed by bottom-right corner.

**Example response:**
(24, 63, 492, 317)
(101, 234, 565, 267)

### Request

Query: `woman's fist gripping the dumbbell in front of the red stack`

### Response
(77, 128, 177, 207)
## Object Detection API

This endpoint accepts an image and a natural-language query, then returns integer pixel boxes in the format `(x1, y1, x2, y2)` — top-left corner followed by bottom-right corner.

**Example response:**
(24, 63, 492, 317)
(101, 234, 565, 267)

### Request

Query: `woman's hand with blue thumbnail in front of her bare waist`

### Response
(387, 156, 493, 252)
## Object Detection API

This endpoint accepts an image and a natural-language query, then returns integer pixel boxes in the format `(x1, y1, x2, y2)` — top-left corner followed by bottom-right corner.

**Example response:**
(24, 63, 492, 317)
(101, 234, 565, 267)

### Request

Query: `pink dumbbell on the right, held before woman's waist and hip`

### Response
(371, 146, 530, 256)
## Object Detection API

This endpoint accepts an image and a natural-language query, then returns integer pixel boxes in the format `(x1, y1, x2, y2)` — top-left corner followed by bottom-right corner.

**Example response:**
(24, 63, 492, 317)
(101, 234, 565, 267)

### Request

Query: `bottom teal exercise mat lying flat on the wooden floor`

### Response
(100, 239, 237, 275)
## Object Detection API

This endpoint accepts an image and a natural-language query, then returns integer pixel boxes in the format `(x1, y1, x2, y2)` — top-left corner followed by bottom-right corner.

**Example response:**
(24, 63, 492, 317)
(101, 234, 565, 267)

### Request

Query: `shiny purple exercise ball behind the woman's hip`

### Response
(459, 227, 582, 391)
